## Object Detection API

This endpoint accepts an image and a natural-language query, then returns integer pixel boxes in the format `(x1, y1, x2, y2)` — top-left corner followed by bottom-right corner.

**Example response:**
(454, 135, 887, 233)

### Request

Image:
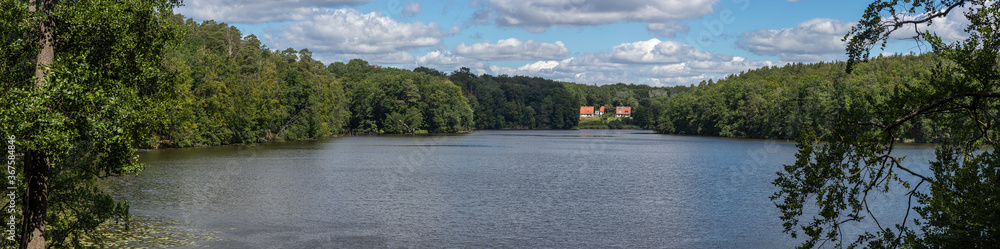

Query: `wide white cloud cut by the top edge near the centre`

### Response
(473, 0, 718, 33)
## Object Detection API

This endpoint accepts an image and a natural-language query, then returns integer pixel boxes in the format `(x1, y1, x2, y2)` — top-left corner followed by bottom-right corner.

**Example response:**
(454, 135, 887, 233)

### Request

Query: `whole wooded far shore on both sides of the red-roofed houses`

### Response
(154, 15, 945, 148)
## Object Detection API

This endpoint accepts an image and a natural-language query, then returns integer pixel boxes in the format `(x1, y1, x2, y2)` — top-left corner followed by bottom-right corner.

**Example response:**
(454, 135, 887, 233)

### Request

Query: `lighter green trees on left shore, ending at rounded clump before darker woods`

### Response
(149, 18, 472, 147)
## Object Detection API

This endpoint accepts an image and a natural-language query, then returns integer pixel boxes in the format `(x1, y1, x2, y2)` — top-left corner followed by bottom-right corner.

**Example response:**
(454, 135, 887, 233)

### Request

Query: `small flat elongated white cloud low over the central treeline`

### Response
(453, 38, 569, 61)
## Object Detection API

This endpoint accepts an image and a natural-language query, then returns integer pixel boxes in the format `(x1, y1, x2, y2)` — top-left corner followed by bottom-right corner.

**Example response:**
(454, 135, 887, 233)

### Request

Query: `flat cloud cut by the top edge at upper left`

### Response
(176, 0, 371, 23)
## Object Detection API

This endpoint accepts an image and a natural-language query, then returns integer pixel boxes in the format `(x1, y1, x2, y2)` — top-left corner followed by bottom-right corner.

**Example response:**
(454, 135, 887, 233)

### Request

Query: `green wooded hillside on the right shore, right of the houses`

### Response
(655, 54, 942, 142)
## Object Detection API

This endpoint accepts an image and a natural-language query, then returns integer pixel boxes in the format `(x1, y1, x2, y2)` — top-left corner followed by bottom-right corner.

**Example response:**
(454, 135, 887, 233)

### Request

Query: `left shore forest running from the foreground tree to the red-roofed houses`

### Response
(152, 15, 687, 148)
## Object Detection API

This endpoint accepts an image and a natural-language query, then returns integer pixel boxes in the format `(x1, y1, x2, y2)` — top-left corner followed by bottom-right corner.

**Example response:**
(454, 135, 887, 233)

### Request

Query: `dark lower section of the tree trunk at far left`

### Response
(21, 151, 49, 249)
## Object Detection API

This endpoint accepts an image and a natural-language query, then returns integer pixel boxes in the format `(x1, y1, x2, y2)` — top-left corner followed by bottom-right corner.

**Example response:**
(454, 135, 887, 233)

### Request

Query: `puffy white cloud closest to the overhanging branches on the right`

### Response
(736, 18, 853, 62)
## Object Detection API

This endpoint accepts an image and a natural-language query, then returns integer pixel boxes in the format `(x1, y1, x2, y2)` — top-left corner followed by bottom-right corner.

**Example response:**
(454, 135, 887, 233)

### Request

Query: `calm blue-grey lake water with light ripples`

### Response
(105, 130, 933, 248)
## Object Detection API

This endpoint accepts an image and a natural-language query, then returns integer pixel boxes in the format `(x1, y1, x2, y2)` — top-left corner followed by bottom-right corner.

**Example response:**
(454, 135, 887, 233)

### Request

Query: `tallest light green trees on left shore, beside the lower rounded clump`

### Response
(160, 19, 348, 147)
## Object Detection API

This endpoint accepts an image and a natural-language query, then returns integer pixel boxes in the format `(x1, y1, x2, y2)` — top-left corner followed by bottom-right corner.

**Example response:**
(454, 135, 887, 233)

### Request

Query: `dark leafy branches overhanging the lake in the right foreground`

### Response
(771, 0, 1000, 248)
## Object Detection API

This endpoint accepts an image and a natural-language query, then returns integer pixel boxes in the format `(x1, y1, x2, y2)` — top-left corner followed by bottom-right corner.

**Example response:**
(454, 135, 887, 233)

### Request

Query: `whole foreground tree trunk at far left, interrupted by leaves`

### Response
(21, 0, 55, 249)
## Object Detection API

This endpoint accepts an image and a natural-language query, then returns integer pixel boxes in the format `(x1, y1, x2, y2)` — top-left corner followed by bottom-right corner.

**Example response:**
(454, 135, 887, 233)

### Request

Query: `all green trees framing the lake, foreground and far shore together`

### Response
(7, 0, 1000, 248)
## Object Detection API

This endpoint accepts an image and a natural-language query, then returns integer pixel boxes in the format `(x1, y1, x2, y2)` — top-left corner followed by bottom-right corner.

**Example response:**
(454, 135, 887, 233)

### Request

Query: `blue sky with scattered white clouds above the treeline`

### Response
(175, 0, 968, 86)
